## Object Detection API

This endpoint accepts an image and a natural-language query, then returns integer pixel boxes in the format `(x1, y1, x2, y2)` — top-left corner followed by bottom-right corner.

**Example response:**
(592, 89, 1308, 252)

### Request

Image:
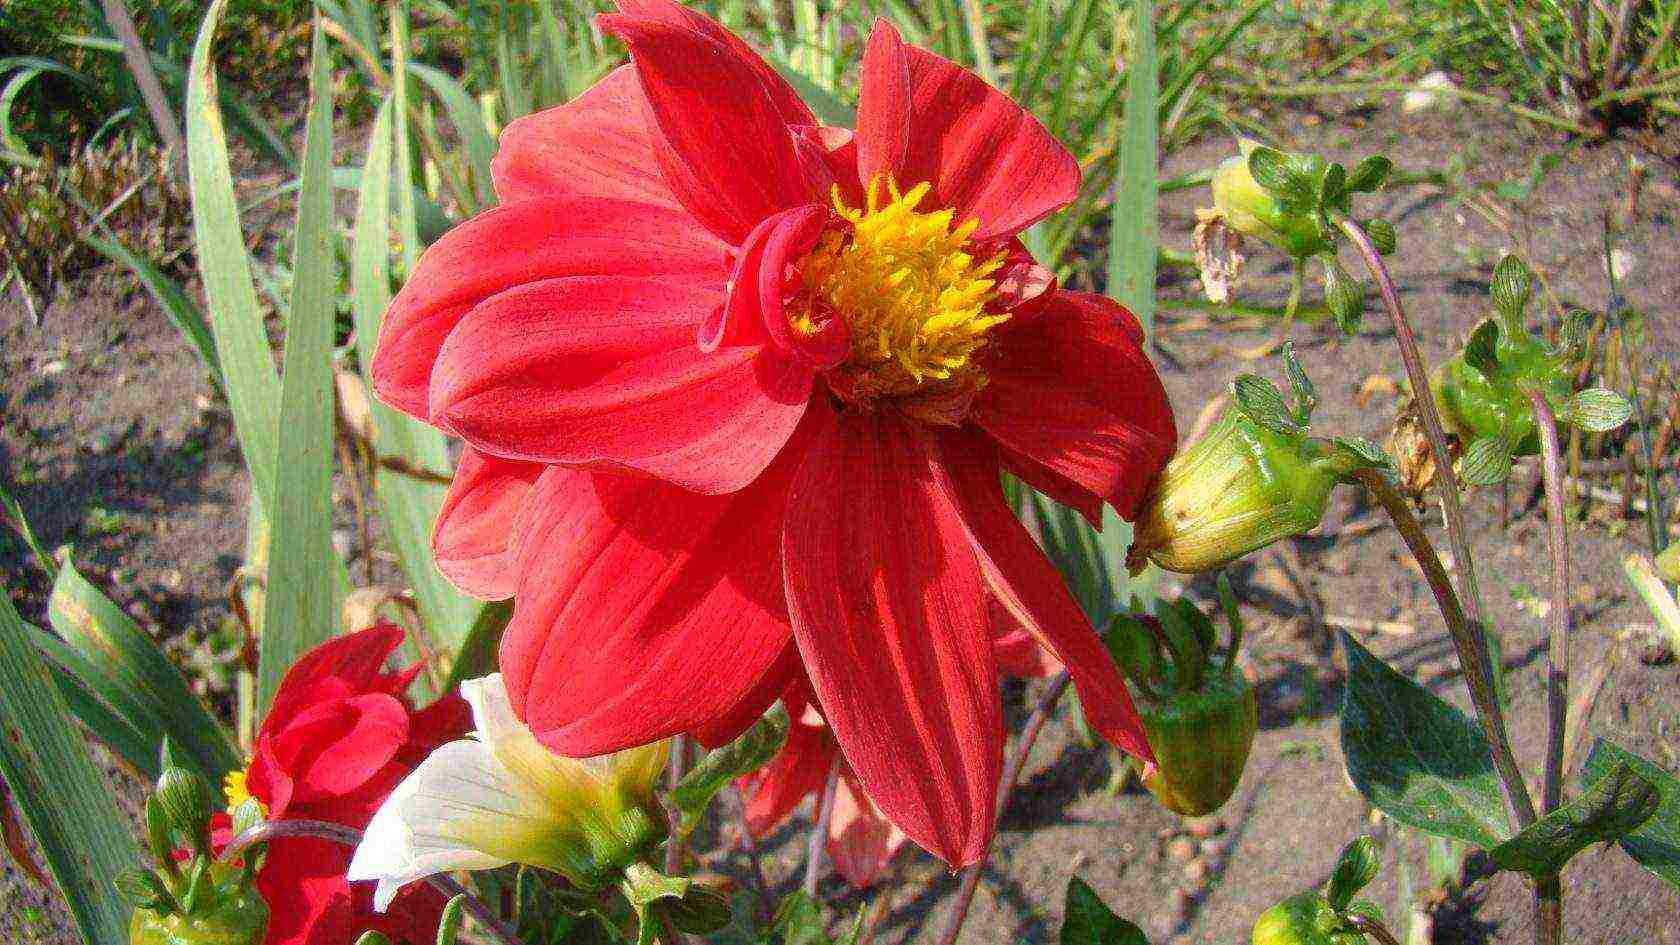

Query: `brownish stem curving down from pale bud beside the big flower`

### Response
(1354, 469, 1536, 829)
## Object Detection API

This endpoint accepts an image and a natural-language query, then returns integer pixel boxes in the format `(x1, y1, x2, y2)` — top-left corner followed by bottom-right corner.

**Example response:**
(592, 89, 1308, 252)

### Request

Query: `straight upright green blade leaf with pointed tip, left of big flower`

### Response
(257, 29, 339, 715)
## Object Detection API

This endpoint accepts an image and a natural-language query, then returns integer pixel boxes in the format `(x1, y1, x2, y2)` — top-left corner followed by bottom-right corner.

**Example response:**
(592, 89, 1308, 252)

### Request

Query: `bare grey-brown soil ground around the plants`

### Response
(0, 93, 1680, 945)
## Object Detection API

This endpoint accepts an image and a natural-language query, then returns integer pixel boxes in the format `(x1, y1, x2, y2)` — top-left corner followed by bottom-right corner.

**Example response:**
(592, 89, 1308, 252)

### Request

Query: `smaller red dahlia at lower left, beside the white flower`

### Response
(218, 624, 472, 945)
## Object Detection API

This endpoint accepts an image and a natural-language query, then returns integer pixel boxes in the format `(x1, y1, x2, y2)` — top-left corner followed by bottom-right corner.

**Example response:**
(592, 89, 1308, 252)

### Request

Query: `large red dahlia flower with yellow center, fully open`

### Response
(371, 0, 1176, 864)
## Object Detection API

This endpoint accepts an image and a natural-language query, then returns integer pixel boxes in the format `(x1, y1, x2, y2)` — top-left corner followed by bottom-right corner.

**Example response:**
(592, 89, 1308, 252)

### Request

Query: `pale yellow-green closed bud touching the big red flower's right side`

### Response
(1126, 409, 1354, 573)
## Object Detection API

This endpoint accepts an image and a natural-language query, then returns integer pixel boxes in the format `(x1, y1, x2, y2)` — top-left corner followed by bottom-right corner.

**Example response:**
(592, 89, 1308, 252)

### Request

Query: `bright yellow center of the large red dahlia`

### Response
(788, 175, 1010, 424)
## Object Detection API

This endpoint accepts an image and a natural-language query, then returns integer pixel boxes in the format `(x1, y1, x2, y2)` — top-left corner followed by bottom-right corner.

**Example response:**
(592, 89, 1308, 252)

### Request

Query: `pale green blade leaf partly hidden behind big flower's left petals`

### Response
(349, 99, 483, 655)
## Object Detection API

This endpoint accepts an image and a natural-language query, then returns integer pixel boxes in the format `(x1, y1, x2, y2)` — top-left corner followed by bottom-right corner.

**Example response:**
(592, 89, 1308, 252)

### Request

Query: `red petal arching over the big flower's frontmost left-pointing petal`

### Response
(371, 197, 727, 420)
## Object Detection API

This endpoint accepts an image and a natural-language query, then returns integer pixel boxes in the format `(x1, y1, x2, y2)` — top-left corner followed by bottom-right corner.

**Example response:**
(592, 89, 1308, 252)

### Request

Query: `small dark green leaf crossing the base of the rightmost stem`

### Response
(1488, 762, 1662, 876)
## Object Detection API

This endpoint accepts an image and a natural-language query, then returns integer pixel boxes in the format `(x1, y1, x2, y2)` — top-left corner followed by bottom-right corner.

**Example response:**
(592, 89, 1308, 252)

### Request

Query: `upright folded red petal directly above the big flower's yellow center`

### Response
(857, 18, 1079, 239)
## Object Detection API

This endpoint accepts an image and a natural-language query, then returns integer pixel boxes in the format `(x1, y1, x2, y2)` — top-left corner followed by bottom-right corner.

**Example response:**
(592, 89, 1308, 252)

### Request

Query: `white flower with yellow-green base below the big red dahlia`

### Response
(348, 673, 669, 911)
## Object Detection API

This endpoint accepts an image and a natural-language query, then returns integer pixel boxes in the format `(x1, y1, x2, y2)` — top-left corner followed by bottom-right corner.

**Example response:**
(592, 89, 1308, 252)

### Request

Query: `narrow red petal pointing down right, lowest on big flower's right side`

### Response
(941, 432, 1154, 763)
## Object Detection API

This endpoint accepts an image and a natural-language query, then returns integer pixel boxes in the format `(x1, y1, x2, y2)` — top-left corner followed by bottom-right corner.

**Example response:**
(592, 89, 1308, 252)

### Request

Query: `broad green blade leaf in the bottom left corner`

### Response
(0, 578, 139, 945)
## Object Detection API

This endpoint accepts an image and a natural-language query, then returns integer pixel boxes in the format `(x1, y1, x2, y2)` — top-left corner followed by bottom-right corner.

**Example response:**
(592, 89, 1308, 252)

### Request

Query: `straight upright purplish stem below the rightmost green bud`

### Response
(1525, 390, 1571, 945)
